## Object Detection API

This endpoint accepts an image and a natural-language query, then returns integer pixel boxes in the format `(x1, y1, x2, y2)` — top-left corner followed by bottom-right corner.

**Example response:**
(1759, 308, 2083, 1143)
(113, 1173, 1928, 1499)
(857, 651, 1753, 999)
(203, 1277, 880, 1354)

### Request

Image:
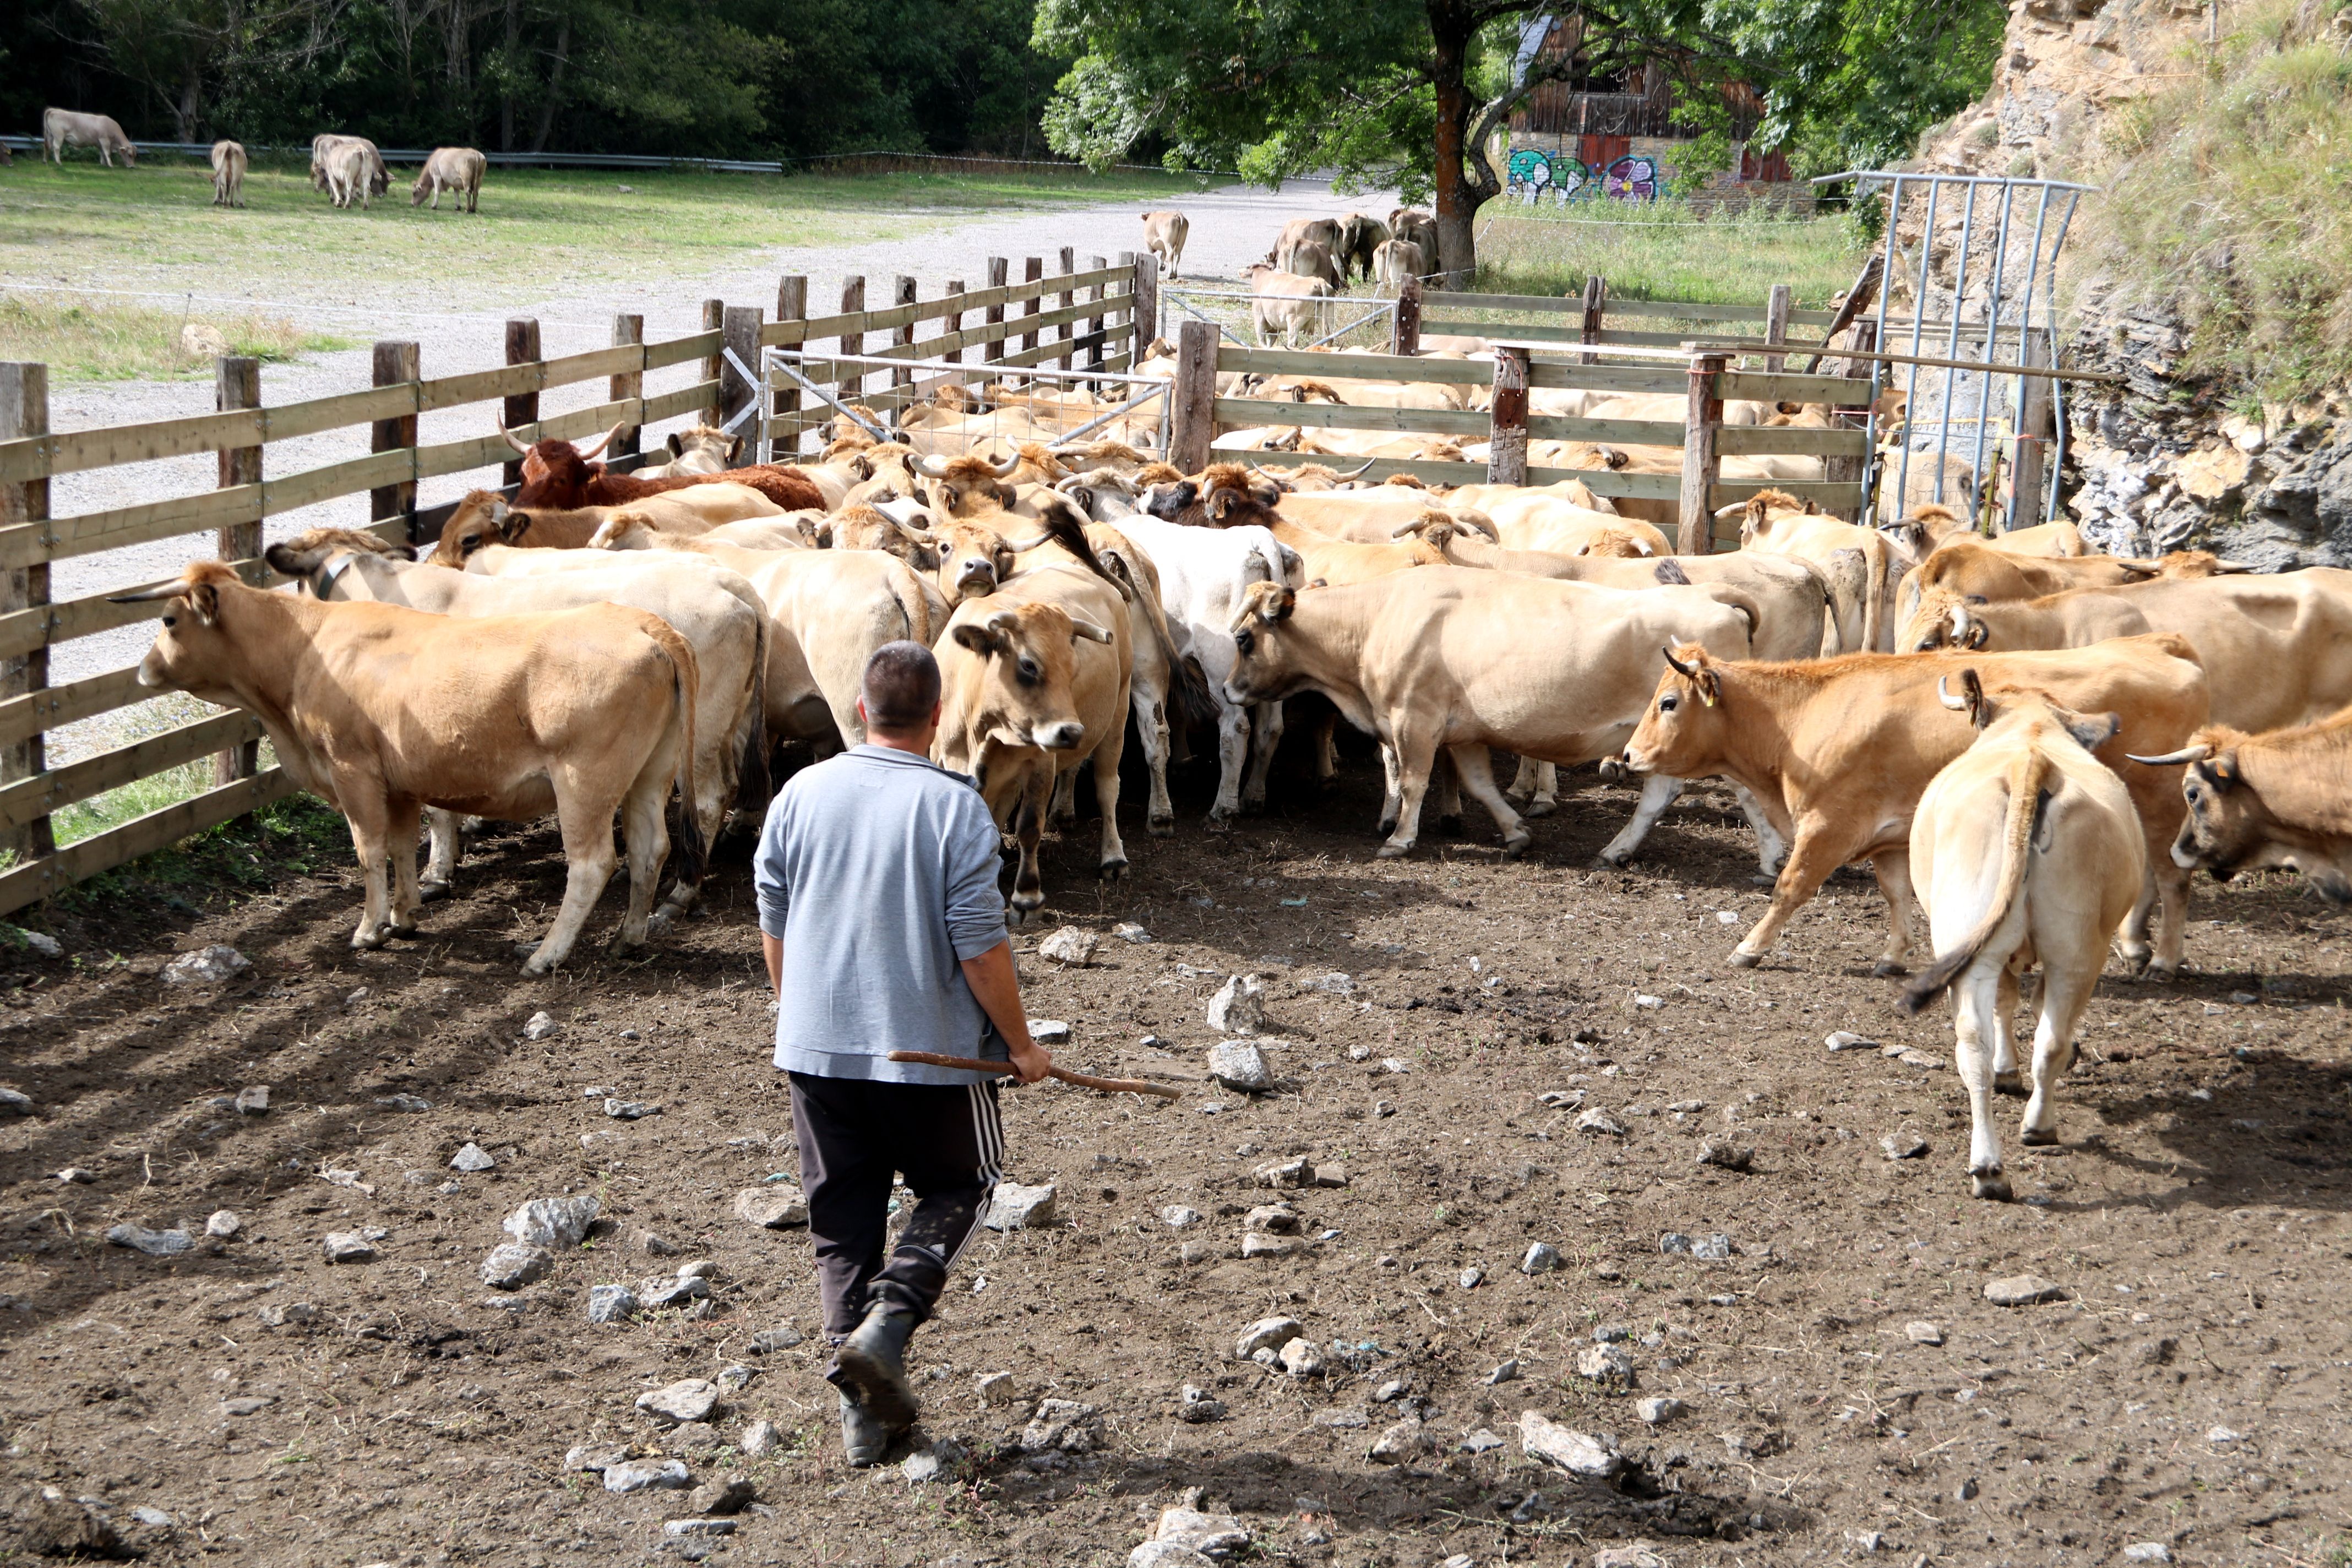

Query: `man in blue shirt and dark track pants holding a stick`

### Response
(753, 642, 1052, 1464)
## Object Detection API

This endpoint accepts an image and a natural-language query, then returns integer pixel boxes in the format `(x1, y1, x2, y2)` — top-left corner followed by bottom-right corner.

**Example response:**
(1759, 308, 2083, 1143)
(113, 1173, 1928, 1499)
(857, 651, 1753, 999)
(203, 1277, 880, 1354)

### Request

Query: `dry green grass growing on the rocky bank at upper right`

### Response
(2086, 0, 2352, 402)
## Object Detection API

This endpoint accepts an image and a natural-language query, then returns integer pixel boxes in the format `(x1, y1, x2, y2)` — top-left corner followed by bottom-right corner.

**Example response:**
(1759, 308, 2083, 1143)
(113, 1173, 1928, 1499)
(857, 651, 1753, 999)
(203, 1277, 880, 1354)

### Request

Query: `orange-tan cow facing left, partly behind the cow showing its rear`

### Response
(1625, 635, 2208, 976)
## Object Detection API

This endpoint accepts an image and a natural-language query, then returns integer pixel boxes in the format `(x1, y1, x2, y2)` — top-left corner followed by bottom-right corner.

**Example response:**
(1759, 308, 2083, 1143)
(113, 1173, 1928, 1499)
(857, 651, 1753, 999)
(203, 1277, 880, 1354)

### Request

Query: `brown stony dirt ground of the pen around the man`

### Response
(0, 726, 2352, 1568)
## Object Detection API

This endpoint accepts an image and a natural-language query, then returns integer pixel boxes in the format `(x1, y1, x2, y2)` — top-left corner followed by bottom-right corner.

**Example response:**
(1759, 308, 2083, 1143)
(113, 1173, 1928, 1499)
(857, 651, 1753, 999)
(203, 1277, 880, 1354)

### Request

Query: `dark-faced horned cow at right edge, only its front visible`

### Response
(2136, 707, 2352, 905)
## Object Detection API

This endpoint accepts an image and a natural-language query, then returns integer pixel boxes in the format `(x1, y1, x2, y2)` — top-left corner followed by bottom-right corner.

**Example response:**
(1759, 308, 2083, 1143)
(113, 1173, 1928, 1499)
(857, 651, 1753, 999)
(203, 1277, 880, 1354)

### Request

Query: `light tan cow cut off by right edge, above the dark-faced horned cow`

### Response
(1914, 567, 2352, 731)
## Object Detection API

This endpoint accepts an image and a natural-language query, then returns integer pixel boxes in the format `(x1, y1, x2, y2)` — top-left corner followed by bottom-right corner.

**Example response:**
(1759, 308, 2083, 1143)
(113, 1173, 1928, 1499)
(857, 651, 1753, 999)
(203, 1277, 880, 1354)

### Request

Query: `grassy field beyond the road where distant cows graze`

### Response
(0, 157, 1197, 311)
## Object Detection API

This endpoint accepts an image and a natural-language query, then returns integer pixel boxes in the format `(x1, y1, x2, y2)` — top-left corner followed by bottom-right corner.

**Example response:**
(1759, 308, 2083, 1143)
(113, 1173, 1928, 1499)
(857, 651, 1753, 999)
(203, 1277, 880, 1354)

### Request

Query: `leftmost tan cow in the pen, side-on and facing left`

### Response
(118, 562, 703, 976)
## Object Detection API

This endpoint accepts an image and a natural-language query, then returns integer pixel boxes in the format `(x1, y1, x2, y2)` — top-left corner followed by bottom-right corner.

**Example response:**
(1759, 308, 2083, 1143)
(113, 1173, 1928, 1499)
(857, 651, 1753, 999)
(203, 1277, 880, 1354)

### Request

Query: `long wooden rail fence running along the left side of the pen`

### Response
(0, 252, 1157, 914)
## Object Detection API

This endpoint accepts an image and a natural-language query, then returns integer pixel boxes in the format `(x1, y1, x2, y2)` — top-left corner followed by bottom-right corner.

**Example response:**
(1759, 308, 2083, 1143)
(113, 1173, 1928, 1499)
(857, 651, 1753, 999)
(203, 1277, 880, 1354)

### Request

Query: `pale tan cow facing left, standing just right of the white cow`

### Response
(1226, 567, 1750, 858)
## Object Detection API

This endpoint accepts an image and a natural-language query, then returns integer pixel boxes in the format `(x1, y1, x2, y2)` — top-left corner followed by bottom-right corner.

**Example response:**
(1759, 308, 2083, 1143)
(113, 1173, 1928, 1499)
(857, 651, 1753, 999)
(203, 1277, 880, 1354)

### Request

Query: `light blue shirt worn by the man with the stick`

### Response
(753, 745, 1009, 1084)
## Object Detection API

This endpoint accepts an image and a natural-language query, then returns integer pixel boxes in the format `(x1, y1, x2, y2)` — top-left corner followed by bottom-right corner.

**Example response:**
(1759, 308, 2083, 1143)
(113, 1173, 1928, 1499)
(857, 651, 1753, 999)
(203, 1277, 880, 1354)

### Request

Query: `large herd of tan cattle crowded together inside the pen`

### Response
(119, 322, 2352, 1196)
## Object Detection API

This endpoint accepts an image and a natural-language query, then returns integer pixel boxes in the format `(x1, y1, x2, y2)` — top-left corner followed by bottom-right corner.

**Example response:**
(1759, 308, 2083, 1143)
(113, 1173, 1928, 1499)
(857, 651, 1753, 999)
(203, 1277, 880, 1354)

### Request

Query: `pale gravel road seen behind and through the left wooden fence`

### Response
(32, 181, 1395, 766)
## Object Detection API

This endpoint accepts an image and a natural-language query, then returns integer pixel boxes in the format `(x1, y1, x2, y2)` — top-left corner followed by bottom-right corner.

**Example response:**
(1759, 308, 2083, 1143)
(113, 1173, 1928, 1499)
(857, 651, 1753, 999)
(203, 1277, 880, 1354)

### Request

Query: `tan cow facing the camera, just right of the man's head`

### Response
(932, 567, 1134, 924)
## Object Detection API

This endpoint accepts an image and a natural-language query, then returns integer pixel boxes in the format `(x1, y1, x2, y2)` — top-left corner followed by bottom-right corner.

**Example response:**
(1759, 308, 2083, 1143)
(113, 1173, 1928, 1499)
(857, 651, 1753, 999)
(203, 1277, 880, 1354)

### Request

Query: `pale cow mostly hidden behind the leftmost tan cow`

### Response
(266, 529, 769, 926)
